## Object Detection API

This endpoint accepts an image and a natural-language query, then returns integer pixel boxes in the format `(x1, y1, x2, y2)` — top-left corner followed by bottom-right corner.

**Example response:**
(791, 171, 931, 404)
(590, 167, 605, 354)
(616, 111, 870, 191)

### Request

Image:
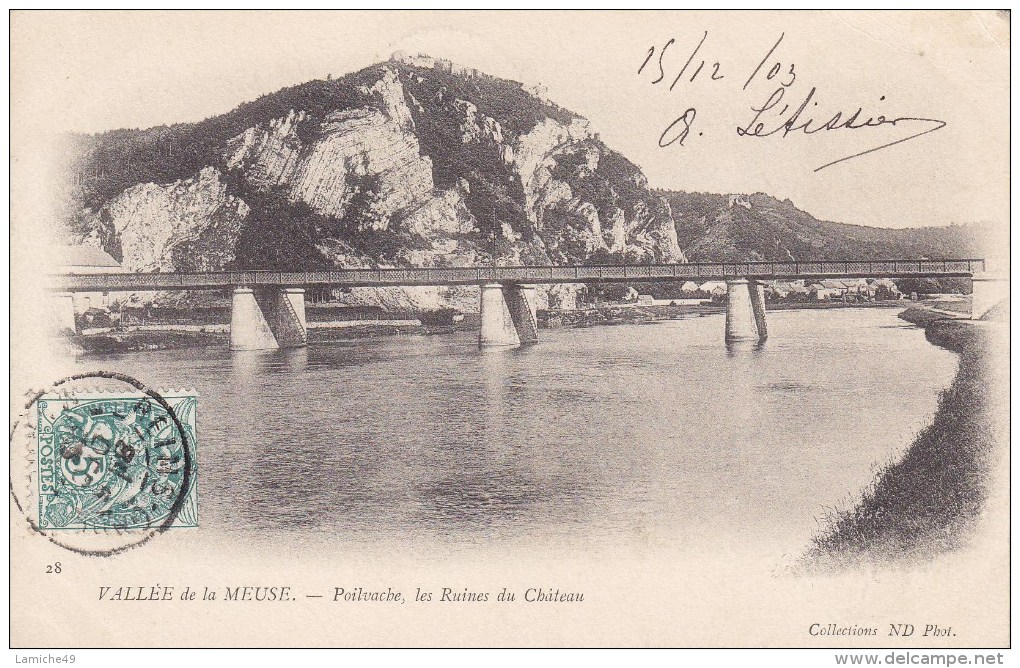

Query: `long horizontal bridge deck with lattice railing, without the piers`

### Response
(49, 259, 984, 292)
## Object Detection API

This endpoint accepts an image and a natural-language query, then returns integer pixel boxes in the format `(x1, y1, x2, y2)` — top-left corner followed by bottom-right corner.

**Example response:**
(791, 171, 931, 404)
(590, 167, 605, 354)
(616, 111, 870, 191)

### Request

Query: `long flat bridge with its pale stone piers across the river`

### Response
(49, 259, 1006, 350)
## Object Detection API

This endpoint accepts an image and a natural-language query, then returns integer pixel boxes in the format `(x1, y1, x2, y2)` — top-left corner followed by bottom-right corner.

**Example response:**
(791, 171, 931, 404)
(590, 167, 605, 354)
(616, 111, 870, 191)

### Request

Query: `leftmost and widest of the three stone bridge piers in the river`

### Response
(231, 288, 308, 350)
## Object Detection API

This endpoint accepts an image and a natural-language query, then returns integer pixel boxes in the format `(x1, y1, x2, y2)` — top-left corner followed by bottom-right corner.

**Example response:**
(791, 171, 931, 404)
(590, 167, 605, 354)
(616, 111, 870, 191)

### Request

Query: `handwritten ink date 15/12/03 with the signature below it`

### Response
(638, 31, 946, 171)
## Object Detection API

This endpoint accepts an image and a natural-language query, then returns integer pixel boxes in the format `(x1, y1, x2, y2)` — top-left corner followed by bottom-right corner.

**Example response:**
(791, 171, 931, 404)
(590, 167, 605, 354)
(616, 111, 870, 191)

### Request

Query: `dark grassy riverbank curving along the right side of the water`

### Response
(799, 306, 1009, 571)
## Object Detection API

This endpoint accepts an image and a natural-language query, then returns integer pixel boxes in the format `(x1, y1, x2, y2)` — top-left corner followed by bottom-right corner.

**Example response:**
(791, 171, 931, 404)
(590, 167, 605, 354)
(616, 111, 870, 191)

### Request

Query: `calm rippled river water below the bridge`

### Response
(77, 309, 956, 556)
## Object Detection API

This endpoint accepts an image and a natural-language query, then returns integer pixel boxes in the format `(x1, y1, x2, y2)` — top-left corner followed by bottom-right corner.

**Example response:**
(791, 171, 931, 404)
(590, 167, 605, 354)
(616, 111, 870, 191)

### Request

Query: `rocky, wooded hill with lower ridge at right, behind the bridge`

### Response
(53, 54, 973, 306)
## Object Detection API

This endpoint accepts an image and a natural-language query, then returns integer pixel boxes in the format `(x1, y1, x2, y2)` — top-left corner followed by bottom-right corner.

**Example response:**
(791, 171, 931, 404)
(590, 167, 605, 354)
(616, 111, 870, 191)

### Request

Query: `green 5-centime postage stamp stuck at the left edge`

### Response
(36, 393, 198, 530)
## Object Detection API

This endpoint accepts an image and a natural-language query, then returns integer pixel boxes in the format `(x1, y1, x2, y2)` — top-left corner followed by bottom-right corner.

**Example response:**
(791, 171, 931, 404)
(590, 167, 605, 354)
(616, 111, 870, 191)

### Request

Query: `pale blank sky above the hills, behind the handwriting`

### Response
(11, 11, 1010, 228)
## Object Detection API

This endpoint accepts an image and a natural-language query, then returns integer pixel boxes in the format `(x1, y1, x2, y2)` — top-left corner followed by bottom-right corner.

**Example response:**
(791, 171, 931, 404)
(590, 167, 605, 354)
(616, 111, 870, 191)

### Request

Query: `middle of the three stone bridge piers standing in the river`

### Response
(478, 282, 539, 348)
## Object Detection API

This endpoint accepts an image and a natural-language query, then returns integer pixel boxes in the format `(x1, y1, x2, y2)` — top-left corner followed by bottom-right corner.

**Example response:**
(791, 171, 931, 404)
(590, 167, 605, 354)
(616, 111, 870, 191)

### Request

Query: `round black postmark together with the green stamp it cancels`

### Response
(10, 371, 198, 556)
